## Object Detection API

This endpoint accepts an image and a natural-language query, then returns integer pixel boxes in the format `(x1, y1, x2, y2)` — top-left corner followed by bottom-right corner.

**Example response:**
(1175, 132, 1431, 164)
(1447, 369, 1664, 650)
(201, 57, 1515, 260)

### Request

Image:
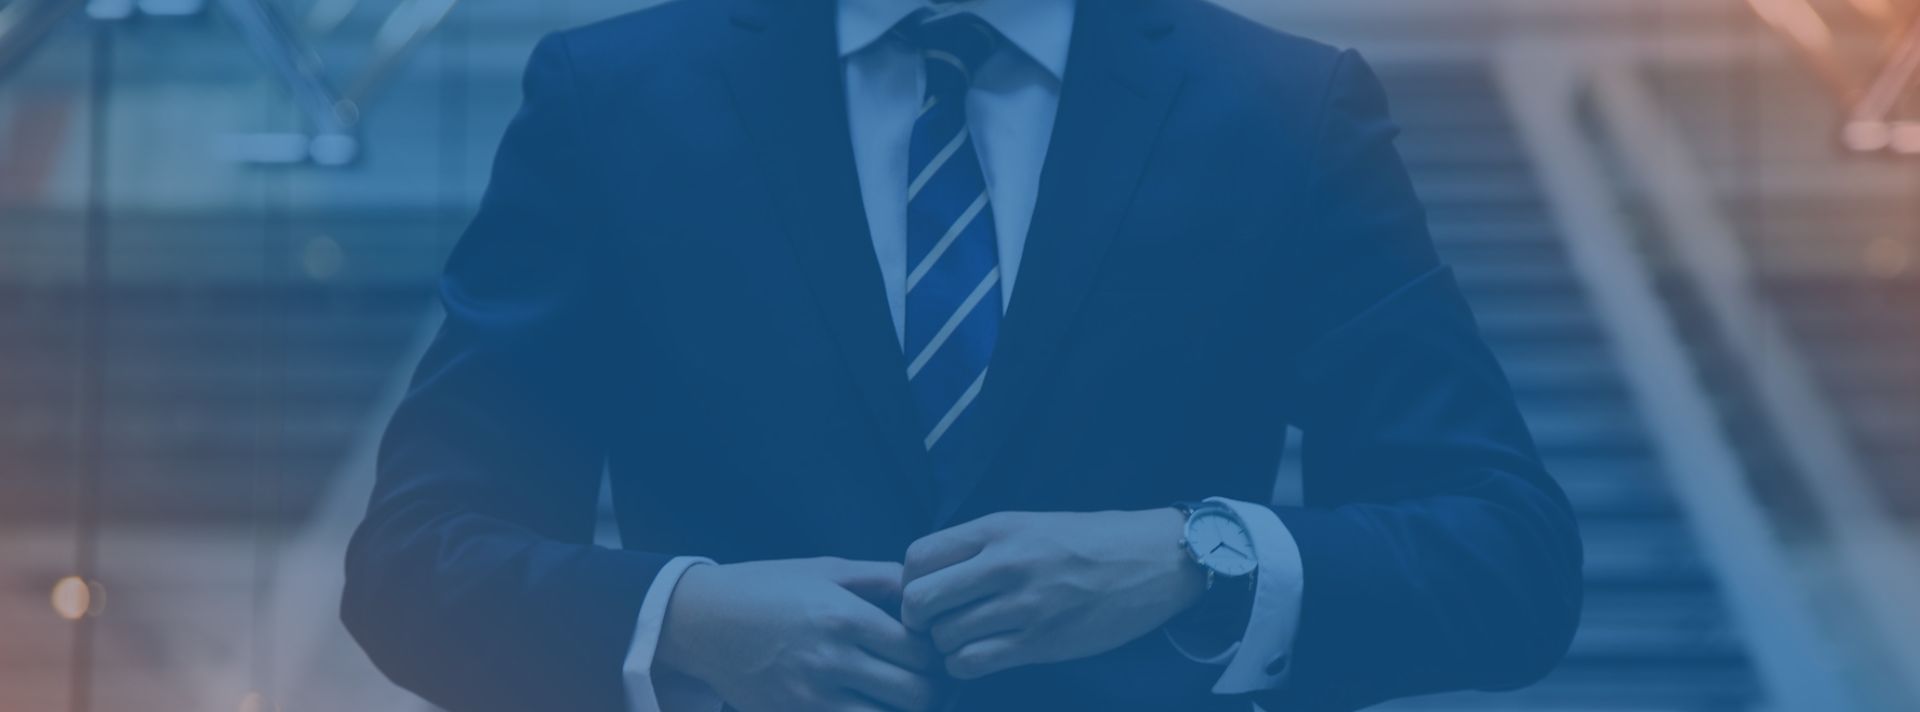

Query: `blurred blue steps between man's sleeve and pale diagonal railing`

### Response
(1380, 63, 1763, 710)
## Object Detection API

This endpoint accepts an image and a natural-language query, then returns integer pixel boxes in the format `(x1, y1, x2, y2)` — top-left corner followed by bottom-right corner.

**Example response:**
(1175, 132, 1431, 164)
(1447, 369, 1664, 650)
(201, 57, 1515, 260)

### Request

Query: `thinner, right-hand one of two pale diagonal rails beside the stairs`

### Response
(1596, 58, 1920, 710)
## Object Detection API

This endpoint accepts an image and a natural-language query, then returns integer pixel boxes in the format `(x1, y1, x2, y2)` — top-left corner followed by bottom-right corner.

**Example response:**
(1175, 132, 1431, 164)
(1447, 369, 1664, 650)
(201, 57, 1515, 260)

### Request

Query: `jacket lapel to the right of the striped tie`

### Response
(935, 0, 1183, 526)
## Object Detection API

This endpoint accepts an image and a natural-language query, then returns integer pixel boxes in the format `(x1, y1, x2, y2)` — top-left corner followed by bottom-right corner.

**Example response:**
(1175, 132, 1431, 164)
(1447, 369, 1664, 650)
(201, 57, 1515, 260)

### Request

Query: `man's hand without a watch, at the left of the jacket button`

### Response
(655, 558, 941, 712)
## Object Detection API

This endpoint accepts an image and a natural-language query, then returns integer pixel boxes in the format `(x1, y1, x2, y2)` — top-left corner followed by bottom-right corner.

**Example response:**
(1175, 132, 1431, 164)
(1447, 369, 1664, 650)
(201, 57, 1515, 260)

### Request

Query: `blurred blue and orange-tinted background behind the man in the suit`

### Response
(0, 0, 1920, 712)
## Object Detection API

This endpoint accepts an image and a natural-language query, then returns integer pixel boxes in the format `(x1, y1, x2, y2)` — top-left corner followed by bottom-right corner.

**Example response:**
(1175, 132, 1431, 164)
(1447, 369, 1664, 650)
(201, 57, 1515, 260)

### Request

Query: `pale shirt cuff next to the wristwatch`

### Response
(1167, 497, 1306, 695)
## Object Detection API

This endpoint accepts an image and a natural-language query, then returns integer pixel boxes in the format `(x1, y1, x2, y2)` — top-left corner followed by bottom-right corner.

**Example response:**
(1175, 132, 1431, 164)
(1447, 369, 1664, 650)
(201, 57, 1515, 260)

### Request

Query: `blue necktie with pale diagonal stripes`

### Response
(899, 12, 1002, 466)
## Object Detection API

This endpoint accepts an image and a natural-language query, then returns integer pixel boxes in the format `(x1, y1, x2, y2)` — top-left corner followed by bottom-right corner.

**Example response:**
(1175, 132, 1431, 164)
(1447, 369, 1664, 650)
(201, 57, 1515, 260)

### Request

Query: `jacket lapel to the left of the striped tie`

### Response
(726, 0, 931, 505)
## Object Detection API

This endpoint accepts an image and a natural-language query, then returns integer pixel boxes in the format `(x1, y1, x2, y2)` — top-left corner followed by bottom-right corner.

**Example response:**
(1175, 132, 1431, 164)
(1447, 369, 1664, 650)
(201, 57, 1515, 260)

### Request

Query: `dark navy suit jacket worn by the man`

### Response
(344, 0, 1580, 710)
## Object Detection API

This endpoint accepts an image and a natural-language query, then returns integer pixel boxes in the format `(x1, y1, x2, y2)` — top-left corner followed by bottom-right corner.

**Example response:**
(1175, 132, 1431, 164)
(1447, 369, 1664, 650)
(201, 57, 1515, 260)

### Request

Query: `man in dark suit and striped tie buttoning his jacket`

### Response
(344, 0, 1580, 712)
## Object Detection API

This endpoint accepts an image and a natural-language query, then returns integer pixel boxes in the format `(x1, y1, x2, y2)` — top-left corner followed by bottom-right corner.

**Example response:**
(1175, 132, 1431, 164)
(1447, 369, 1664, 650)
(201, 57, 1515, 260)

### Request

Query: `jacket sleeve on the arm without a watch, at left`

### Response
(342, 36, 670, 712)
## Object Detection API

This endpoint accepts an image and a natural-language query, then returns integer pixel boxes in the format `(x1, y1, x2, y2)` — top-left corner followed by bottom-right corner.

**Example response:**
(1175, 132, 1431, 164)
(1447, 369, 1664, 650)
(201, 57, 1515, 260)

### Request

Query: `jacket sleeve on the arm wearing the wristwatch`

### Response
(1256, 52, 1582, 710)
